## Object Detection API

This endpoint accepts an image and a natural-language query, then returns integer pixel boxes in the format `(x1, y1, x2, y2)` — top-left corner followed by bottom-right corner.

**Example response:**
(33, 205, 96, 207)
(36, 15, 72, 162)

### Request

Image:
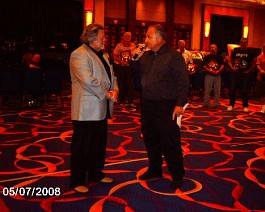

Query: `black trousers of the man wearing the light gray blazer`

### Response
(70, 119, 107, 187)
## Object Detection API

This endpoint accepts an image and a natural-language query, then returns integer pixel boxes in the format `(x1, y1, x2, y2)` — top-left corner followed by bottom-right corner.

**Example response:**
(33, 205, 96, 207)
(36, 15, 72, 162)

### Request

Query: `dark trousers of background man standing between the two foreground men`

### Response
(115, 65, 135, 103)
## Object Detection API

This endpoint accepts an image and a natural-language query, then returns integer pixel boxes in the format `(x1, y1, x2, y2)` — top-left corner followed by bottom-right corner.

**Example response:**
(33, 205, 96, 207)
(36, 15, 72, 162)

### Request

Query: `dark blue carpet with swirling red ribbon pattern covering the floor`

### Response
(0, 96, 265, 212)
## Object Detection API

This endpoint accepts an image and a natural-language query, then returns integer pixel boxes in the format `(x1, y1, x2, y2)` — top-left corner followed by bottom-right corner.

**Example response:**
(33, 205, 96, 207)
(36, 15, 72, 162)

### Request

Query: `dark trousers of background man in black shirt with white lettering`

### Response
(230, 72, 250, 107)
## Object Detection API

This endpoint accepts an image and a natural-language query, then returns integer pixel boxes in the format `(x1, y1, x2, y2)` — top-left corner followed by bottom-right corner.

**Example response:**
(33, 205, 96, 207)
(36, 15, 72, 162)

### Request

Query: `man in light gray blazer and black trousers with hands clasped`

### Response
(70, 24, 119, 193)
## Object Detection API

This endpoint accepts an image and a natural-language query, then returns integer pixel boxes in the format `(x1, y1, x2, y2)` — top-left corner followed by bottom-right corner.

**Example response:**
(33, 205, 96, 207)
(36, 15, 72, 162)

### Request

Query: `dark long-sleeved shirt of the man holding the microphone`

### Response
(138, 44, 189, 106)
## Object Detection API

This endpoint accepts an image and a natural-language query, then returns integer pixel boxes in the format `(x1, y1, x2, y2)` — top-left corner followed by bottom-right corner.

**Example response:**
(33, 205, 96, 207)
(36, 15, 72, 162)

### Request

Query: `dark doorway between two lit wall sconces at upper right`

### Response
(210, 15, 243, 54)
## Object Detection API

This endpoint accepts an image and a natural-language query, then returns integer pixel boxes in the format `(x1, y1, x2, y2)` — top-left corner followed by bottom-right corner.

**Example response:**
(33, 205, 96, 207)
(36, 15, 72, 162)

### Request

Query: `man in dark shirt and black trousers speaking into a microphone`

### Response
(133, 24, 189, 189)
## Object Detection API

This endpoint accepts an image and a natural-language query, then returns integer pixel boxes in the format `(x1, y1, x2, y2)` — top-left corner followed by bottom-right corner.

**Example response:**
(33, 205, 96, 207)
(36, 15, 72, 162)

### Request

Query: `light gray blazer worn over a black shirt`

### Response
(70, 44, 118, 121)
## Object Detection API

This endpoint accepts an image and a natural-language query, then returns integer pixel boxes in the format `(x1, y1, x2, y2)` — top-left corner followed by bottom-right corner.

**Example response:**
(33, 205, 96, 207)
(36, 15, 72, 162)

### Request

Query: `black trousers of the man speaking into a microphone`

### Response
(141, 100, 184, 180)
